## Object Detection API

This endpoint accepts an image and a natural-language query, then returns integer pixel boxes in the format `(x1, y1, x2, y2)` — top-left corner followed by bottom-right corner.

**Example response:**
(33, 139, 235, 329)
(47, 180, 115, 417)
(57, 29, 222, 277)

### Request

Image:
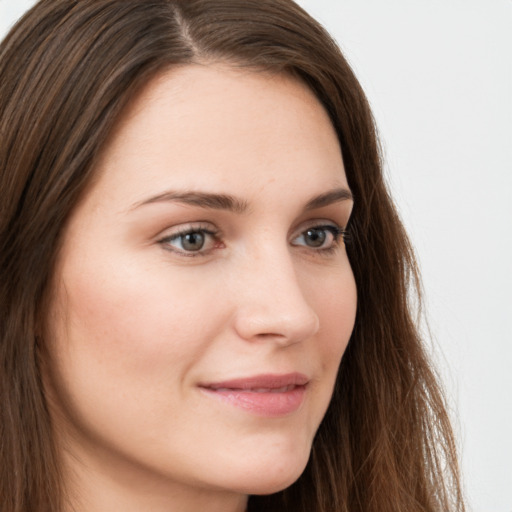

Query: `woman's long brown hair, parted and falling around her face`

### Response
(0, 0, 464, 512)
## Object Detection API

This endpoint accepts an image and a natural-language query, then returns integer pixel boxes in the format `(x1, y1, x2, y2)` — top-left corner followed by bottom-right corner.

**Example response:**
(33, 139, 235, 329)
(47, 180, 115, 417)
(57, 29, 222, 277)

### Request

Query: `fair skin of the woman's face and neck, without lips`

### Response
(44, 64, 356, 512)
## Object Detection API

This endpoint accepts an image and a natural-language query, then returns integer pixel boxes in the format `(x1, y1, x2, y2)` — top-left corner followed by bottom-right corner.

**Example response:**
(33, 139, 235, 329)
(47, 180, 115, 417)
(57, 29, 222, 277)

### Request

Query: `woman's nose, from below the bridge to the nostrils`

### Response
(235, 246, 320, 345)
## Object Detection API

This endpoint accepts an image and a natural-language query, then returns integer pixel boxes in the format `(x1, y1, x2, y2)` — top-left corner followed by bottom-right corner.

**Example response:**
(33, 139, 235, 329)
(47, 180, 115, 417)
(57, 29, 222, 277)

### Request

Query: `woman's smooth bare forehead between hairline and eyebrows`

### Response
(88, 65, 346, 210)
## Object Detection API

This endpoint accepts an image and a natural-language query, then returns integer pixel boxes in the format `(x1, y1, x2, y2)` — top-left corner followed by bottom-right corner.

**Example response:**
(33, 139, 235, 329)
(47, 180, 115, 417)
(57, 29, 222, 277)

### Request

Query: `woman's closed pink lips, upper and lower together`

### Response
(199, 373, 309, 417)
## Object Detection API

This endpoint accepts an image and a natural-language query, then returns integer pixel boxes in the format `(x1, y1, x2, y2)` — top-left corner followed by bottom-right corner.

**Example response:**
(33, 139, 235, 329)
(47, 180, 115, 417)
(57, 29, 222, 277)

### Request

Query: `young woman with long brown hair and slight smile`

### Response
(0, 0, 464, 512)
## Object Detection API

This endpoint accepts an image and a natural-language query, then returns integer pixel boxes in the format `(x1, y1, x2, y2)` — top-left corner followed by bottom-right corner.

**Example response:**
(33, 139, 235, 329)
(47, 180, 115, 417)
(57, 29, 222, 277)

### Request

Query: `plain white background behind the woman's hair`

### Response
(0, 0, 512, 512)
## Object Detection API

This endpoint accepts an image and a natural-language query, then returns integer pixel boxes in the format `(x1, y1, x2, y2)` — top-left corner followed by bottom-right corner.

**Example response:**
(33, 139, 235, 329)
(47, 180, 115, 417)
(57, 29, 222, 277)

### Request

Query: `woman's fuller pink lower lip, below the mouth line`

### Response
(202, 386, 306, 418)
